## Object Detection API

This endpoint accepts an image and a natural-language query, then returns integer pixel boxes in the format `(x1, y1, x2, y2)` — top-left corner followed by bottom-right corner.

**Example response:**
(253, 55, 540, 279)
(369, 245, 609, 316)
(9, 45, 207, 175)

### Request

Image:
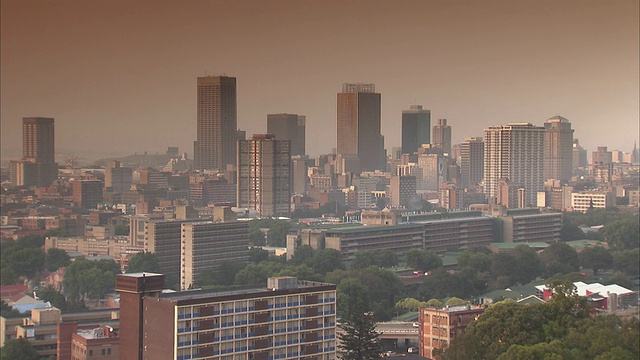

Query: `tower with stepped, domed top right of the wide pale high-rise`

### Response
(544, 116, 573, 181)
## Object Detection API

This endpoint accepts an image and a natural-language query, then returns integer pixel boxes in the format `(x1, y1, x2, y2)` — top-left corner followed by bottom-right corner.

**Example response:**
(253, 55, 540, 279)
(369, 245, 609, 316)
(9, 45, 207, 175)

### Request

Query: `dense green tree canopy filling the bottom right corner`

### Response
(441, 283, 640, 360)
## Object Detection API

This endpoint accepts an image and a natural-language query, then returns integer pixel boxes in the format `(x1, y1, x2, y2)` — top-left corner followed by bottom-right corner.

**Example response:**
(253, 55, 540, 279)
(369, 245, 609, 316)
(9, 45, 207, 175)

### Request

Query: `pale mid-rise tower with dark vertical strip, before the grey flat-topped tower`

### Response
(236, 135, 291, 217)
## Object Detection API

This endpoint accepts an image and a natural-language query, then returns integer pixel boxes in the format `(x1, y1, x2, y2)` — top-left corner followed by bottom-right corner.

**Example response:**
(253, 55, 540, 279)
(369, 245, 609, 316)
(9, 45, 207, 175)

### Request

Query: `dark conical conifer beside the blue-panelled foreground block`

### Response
(338, 302, 381, 360)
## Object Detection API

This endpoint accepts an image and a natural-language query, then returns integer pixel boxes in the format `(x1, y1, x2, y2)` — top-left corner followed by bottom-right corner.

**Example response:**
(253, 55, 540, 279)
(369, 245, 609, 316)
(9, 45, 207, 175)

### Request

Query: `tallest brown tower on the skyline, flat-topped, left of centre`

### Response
(193, 76, 238, 170)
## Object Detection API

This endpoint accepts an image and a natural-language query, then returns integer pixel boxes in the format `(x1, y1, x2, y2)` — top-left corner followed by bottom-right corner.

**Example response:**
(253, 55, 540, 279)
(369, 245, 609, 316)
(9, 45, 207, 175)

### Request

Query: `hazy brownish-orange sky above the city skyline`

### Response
(0, 0, 640, 159)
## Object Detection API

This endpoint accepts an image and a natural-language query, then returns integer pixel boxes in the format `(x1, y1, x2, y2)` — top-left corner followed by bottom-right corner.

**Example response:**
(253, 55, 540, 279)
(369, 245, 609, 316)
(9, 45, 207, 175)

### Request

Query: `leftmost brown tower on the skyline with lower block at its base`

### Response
(10, 117, 58, 187)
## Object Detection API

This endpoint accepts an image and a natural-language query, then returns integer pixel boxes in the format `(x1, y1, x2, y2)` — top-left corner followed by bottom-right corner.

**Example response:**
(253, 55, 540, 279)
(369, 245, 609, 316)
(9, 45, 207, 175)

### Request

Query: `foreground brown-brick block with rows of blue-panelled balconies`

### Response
(116, 273, 336, 360)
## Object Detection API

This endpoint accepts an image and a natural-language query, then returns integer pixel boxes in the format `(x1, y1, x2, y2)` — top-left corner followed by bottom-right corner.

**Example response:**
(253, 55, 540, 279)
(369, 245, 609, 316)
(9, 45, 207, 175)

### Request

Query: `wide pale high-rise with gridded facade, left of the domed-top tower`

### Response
(484, 123, 545, 206)
